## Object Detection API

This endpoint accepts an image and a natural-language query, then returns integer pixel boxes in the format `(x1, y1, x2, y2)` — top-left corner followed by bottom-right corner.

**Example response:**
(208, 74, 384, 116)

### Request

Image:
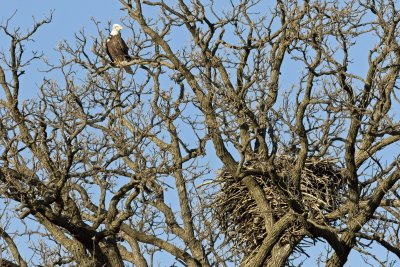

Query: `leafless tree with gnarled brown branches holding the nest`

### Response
(0, 0, 400, 267)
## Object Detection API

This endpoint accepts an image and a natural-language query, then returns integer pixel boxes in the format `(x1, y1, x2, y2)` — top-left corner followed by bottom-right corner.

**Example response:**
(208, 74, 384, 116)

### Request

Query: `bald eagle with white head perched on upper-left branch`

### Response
(106, 24, 133, 74)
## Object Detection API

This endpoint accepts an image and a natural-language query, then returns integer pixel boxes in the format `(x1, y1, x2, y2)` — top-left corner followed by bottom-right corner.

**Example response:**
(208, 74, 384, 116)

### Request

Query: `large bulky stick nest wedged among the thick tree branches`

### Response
(213, 155, 345, 255)
